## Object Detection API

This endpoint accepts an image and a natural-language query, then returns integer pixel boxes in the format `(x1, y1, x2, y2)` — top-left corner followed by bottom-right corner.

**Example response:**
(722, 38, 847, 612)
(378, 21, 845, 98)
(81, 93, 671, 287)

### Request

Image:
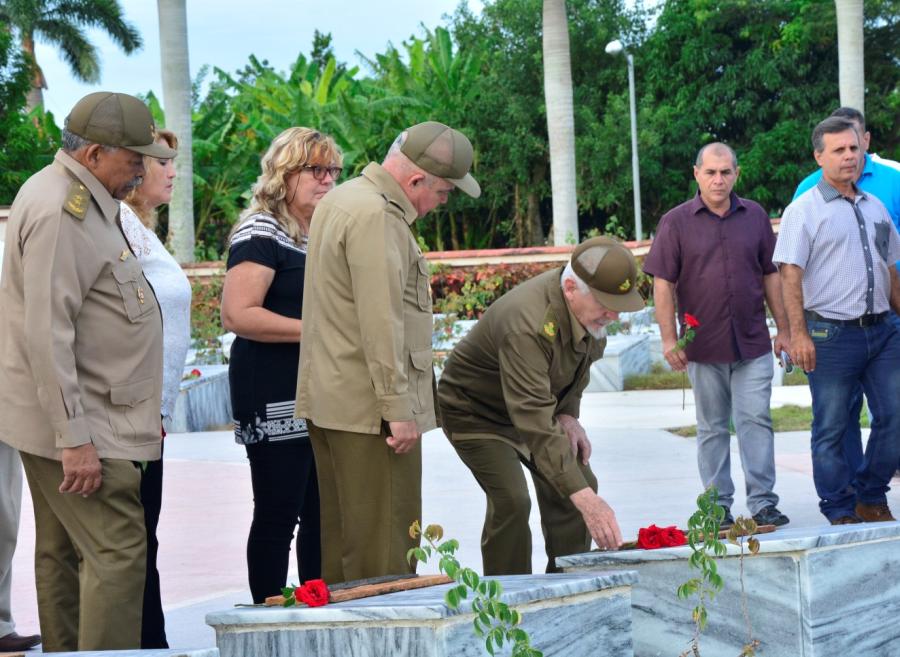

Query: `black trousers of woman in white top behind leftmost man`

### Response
(141, 438, 169, 649)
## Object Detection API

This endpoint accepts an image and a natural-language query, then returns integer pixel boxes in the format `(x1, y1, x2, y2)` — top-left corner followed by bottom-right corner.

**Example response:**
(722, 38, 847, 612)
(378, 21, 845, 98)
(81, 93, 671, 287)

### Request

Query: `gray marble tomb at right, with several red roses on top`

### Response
(557, 522, 900, 657)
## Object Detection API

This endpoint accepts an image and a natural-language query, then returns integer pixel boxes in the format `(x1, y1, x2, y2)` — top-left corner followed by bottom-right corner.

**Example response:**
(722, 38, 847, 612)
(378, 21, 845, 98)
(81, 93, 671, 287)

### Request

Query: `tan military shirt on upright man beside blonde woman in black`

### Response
(296, 163, 436, 434)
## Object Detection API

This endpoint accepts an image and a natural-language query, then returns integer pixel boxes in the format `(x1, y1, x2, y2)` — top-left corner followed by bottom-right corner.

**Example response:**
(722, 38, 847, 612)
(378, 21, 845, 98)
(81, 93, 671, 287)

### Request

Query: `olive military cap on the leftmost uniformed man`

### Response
(66, 91, 175, 159)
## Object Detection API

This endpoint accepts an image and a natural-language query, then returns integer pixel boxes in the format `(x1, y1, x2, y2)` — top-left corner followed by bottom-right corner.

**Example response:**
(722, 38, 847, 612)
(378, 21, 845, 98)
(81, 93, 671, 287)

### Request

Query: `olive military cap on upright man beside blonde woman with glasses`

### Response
(400, 121, 481, 198)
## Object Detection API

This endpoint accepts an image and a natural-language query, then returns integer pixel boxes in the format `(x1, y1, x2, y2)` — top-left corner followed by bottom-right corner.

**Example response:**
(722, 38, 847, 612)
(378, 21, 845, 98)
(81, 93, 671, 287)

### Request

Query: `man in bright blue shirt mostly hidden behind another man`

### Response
(793, 107, 900, 470)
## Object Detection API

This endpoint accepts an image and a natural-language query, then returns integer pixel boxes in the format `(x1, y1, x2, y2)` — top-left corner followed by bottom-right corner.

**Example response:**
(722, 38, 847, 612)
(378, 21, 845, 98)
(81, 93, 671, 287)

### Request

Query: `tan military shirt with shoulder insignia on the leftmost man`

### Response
(0, 151, 162, 460)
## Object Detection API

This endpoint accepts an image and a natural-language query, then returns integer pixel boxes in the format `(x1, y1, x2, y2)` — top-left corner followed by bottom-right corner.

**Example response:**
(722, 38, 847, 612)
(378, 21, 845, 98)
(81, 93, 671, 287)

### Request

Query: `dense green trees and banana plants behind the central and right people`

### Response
(0, 0, 900, 252)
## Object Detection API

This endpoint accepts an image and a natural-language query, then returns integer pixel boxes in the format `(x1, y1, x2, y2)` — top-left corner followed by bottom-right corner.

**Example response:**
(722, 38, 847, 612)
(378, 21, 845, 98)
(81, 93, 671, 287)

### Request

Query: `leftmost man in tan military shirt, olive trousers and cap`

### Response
(0, 92, 175, 652)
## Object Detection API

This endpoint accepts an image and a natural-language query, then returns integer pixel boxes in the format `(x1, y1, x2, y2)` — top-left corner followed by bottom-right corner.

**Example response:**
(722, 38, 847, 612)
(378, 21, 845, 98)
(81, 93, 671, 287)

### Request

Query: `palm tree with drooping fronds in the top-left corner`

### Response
(0, 0, 142, 110)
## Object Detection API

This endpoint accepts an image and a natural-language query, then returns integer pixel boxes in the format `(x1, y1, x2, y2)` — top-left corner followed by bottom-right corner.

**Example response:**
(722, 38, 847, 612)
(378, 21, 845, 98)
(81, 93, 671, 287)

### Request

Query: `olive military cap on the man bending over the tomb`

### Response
(572, 237, 644, 312)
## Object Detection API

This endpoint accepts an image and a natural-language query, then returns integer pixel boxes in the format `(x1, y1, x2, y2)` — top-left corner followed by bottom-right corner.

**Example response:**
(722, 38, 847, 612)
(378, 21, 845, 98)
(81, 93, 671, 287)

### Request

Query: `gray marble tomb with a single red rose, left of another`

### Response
(206, 571, 636, 657)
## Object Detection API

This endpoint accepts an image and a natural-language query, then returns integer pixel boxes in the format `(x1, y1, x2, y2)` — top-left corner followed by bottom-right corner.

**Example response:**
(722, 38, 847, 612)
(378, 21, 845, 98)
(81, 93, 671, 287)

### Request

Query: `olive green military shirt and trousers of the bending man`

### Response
(438, 269, 606, 575)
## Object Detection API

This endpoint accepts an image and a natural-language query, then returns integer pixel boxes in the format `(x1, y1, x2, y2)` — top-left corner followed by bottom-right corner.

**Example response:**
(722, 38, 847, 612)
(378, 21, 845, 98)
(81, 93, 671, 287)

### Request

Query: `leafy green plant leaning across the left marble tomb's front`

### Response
(406, 520, 544, 657)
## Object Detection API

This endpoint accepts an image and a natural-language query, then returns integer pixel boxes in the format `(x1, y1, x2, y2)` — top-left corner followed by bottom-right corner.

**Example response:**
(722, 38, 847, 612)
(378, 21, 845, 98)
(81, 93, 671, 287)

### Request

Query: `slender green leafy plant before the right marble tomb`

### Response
(678, 486, 728, 657)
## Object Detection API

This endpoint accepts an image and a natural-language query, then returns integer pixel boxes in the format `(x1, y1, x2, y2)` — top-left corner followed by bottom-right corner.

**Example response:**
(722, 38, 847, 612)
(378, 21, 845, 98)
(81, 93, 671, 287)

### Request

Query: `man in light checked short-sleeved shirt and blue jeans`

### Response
(773, 117, 900, 524)
